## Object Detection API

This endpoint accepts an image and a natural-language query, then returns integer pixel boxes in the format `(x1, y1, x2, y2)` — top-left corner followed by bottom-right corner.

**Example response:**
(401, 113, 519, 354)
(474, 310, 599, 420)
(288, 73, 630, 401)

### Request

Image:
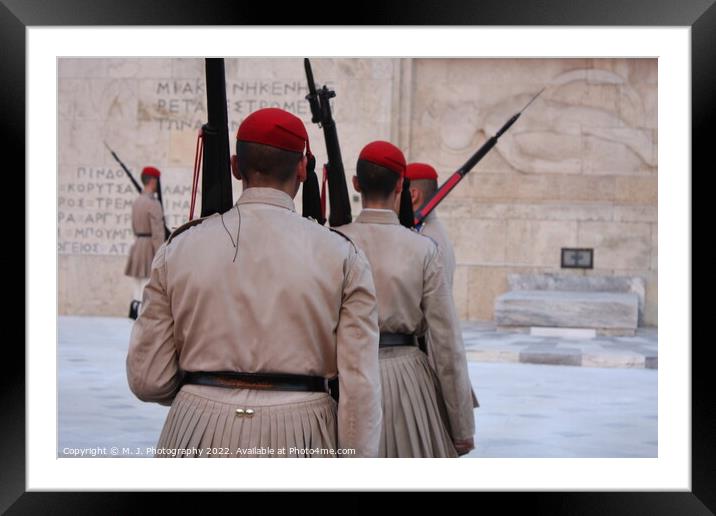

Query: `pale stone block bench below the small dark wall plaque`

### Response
(495, 274, 644, 335)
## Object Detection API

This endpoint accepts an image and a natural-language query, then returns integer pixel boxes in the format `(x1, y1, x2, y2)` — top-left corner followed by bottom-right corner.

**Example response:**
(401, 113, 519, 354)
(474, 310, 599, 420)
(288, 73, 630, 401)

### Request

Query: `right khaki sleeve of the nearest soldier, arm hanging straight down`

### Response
(336, 247, 383, 457)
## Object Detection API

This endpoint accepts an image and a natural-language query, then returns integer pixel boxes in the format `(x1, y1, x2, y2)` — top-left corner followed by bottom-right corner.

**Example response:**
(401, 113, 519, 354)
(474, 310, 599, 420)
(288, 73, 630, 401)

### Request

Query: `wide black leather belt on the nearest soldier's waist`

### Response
(184, 371, 330, 392)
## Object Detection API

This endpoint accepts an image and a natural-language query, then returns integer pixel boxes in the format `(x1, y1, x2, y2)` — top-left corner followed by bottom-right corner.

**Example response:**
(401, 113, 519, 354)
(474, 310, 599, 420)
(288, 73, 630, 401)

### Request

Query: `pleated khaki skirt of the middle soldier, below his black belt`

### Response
(379, 346, 457, 457)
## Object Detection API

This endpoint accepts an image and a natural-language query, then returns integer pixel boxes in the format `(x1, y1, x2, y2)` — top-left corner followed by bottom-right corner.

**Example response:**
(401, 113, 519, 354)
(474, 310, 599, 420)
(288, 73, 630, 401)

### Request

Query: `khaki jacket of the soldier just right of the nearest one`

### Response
(340, 210, 475, 440)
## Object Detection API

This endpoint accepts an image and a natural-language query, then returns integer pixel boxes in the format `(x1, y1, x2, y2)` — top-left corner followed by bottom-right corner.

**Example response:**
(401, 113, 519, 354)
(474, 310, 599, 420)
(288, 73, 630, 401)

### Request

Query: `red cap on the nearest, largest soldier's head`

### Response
(236, 108, 311, 154)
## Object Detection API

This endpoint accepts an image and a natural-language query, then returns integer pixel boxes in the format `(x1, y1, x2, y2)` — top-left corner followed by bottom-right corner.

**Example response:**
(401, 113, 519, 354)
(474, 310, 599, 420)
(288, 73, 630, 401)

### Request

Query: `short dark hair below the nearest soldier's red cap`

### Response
(236, 141, 303, 183)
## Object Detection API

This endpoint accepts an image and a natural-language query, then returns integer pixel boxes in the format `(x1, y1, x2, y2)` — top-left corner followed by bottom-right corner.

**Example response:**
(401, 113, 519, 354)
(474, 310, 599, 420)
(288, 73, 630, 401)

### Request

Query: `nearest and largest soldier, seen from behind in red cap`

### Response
(127, 109, 381, 457)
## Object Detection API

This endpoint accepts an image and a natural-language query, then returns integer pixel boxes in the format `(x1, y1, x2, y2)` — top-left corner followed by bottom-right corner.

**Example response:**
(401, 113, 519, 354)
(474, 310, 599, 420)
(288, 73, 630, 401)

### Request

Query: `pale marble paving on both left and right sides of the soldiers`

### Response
(57, 317, 657, 458)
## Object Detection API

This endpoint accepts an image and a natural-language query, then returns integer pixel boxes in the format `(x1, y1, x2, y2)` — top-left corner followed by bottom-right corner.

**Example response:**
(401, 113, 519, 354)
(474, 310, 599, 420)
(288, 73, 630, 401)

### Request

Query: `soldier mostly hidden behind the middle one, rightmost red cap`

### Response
(405, 163, 480, 408)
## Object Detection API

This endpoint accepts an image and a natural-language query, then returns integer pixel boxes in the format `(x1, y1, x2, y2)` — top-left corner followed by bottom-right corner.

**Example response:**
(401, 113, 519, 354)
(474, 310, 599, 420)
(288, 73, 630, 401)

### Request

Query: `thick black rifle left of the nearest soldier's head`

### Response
(201, 58, 234, 217)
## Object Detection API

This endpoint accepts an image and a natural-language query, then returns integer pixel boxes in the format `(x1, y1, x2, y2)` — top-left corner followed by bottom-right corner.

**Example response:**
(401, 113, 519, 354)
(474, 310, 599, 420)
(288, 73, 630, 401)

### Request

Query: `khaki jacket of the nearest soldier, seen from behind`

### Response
(127, 188, 382, 457)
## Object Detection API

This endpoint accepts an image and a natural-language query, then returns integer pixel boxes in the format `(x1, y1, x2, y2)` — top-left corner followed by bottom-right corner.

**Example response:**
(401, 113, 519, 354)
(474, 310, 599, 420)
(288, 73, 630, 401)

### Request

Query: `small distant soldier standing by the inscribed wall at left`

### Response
(124, 167, 164, 319)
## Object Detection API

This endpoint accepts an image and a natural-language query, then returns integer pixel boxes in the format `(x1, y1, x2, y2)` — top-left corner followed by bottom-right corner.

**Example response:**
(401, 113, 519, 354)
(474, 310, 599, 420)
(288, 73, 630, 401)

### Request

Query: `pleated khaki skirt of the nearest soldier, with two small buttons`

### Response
(155, 385, 337, 458)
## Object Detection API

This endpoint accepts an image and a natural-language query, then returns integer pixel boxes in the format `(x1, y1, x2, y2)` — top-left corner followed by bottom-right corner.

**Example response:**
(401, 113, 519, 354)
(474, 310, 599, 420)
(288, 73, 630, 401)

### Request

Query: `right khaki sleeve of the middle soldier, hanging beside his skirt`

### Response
(422, 247, 475, 441)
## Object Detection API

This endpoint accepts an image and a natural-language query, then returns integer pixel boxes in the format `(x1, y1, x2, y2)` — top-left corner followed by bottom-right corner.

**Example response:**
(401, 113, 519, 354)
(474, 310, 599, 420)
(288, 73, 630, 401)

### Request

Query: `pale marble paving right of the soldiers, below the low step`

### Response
(467, 362, 658, 458)
